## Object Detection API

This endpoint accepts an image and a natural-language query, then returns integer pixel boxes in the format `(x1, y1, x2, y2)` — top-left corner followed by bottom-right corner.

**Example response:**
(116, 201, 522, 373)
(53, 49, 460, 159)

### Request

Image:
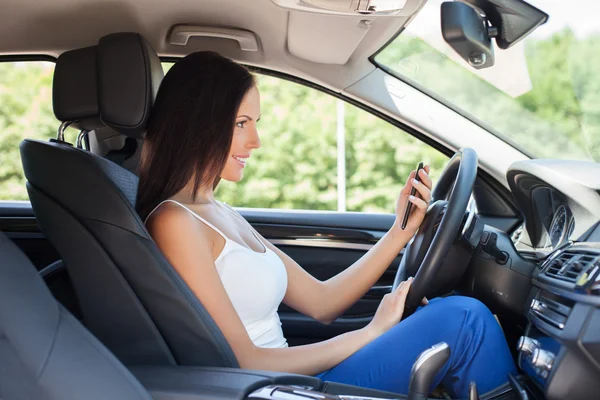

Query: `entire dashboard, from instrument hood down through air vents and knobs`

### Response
(507, 160, 600, 399)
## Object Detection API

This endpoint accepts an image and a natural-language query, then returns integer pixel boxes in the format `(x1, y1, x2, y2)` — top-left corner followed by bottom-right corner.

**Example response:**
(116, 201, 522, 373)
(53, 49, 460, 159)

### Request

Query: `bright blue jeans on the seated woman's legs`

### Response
(317, 296, 516, 398)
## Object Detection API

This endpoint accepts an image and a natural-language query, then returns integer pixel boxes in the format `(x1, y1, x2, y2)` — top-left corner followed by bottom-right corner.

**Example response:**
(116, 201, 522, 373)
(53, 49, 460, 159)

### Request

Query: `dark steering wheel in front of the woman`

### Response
(392, 148, 483, 318)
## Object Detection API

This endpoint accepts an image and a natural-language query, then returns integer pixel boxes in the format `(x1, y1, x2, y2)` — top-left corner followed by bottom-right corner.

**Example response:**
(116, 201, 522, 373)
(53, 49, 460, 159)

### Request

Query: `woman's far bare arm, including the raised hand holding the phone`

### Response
(251, 167, 432, 324)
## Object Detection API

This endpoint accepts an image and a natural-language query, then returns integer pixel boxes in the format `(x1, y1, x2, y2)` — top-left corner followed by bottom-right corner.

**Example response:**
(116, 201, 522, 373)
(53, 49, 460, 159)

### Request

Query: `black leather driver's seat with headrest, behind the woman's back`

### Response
(21, 33, 239, 367)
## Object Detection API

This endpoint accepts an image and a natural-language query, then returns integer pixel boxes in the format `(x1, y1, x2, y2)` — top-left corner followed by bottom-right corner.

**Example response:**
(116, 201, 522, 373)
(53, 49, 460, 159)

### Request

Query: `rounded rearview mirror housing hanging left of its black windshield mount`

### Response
(441, 2, 494, 69)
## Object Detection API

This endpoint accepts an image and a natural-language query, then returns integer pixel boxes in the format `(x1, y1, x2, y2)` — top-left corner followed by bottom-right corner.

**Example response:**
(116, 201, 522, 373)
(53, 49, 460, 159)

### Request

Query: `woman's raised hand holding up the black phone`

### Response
(394, 165, 432, 234)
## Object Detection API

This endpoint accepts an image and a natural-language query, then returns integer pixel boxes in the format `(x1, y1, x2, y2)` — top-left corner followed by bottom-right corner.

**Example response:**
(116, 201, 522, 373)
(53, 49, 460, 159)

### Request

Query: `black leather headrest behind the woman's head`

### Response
(53, 32, 163, 138)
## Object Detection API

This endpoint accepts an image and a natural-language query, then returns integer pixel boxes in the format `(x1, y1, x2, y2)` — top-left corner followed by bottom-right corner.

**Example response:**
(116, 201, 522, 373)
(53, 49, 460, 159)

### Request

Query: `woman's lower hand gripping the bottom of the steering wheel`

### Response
(366, 278, 413, 337)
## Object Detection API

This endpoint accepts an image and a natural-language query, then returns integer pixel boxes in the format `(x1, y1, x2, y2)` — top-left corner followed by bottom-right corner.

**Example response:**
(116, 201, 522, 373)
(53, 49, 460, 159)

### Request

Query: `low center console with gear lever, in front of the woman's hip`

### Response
(130, 343, 511, 400)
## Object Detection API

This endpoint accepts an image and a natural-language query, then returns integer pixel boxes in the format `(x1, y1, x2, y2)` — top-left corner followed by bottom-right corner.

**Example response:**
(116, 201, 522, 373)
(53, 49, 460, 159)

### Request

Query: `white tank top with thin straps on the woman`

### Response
(144, 200, 288, 347)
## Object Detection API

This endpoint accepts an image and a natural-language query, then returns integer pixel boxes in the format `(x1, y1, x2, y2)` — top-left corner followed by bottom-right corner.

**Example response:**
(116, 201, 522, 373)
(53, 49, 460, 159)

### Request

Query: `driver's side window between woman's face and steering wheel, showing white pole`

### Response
(216, 75, 448, 213)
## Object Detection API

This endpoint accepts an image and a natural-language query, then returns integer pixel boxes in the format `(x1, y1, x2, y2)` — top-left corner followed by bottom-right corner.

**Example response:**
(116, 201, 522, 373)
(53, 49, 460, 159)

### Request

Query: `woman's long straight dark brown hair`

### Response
(136, 51, 255, 218)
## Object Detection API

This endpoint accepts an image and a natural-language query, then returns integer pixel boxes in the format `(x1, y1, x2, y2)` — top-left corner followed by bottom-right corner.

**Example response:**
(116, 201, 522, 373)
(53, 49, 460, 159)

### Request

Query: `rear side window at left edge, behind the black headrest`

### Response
(0, 61, 59, 200)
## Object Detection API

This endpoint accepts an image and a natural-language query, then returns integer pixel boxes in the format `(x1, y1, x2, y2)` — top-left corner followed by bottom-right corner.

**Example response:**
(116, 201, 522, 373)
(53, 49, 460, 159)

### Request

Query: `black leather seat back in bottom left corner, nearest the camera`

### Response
(0, 233, 150, 400)
